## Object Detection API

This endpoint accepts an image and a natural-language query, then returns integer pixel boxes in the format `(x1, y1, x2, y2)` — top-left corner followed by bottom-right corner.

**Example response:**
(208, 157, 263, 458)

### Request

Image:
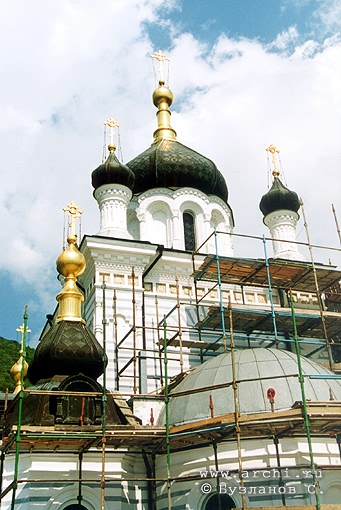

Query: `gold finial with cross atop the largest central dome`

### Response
(151, 50, 176, 142)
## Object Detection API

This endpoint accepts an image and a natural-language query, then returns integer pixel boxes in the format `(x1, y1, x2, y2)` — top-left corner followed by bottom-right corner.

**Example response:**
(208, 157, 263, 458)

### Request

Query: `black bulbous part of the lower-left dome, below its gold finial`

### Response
(27, 320, 103, 384)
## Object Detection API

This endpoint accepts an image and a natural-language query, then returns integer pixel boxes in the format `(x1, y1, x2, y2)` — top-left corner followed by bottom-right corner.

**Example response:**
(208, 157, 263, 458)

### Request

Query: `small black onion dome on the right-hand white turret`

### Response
(259, 177, 300, 216)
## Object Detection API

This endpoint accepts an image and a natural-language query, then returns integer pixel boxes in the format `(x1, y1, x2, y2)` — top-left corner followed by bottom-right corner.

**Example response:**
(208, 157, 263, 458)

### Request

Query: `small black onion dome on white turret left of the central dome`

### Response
(91, 144, 135, 190)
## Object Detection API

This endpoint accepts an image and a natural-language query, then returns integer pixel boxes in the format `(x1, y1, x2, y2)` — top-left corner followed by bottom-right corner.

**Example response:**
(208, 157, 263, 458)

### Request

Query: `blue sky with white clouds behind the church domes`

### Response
(0, 0, 341, 345)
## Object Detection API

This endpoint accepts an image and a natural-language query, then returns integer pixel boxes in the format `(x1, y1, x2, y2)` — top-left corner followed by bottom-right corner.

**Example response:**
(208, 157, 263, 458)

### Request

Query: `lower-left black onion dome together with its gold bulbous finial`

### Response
(28, 234, 103, 384)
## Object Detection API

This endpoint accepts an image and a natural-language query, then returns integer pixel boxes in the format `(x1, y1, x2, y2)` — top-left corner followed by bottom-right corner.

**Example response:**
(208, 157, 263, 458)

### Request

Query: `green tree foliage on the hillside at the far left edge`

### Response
(0, 337, 34, 392)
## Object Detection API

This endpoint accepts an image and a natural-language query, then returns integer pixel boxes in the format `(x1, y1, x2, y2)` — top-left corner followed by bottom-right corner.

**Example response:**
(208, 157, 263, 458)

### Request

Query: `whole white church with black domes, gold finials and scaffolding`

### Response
(0, 56, 341, 510)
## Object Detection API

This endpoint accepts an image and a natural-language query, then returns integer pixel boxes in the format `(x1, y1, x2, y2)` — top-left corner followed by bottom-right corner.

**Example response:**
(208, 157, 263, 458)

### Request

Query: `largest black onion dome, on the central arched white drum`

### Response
(127, 138, 228, 203)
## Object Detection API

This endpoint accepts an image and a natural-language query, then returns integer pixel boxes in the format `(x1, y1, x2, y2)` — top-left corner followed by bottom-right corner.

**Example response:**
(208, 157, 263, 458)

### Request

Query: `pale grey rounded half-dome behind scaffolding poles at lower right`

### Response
(158, 348, 341, 425)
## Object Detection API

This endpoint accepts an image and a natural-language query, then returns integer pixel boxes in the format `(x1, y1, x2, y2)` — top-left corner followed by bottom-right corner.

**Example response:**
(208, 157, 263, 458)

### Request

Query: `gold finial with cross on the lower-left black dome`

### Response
(56, 202, 86, 322)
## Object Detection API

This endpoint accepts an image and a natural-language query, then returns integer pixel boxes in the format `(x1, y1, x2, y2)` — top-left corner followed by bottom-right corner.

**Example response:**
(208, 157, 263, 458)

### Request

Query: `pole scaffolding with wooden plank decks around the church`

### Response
(0, 231, 341, 510)
